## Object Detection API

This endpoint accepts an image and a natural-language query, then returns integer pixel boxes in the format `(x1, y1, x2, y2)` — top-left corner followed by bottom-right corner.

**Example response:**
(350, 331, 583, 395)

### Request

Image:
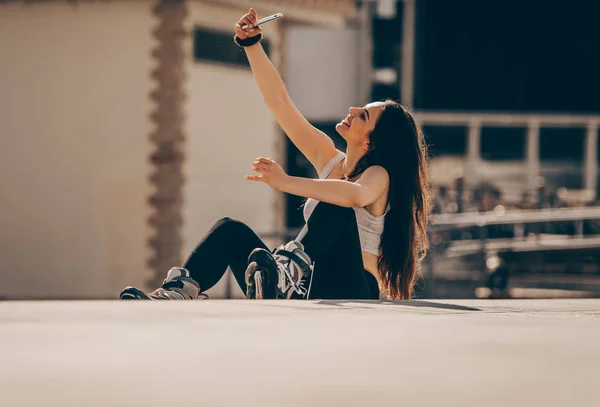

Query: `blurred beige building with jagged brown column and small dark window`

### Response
(0, 0, 355, 298)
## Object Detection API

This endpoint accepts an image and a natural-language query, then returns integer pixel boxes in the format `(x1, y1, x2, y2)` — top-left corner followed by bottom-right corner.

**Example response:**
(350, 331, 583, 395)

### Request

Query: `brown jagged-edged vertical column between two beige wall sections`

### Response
(148, 0, 188, 288)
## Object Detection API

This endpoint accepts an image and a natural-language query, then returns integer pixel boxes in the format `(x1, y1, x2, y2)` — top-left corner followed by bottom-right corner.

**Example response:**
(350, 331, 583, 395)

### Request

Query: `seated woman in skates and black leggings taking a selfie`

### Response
(121, 9, 430, 299)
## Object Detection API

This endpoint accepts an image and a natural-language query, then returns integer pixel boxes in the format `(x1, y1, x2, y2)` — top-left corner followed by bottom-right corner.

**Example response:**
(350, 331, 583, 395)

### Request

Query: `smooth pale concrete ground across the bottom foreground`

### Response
(0, 299, 600, 407)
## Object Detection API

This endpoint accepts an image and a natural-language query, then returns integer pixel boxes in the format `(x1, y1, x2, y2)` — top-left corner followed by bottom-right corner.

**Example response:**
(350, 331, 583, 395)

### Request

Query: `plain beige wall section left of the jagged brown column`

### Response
(0, 1, 155, 298)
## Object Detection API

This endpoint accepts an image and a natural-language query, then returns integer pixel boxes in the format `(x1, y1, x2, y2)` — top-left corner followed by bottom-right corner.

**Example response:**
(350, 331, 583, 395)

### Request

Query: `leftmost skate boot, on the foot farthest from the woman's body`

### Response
(119, 267, 208, 300)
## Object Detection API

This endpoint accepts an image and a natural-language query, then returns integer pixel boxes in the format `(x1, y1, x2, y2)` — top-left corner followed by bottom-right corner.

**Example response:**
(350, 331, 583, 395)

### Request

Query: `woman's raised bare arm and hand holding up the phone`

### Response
(235, 8, 337, 173)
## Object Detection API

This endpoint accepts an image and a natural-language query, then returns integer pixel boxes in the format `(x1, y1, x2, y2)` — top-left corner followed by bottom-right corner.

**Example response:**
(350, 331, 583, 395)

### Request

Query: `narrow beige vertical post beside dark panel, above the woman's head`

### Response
(400, 0, 416, 107)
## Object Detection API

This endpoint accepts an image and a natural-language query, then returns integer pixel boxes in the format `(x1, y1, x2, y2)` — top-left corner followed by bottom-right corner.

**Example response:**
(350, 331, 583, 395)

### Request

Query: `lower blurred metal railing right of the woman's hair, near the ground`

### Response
(424, 207, 600, 296)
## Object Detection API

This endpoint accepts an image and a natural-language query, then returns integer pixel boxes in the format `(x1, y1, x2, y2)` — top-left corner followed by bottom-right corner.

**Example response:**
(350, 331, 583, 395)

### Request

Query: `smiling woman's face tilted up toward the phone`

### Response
(335, 102, 385, 149)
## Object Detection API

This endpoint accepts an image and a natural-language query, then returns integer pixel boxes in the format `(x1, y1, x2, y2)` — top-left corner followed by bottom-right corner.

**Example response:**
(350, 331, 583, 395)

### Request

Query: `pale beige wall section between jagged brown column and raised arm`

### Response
(183, 3, 283, 297)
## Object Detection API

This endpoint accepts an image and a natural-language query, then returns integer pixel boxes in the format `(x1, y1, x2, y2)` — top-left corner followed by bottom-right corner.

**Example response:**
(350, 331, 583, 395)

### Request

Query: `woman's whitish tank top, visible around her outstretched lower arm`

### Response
(303, 151, 390, 256)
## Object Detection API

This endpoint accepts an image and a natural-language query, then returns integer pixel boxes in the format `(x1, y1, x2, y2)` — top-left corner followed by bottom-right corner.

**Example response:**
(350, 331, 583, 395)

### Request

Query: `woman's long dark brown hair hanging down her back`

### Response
(346, 99, 431, 300)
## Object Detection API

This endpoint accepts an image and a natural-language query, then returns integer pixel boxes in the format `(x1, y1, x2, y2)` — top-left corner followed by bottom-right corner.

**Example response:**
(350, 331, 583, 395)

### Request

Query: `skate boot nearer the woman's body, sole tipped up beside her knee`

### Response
(246, 240, 314, 299)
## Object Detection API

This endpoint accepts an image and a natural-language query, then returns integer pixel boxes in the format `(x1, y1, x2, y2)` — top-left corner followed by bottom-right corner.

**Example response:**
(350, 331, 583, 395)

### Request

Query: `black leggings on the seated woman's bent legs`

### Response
(183, 202, 379, 299)
